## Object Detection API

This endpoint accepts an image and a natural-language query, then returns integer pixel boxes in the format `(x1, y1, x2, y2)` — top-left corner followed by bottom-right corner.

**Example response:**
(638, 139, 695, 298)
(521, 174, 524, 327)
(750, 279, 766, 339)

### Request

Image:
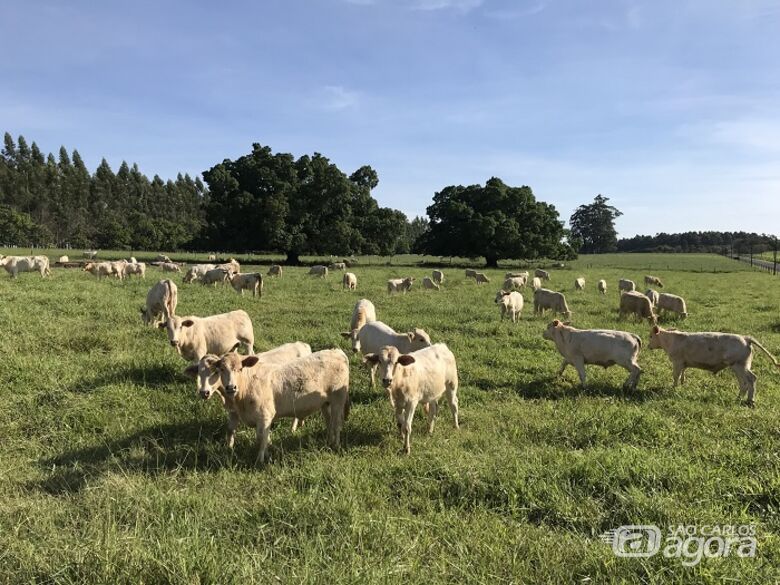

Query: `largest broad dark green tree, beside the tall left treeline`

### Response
(203, 144, 406, 264)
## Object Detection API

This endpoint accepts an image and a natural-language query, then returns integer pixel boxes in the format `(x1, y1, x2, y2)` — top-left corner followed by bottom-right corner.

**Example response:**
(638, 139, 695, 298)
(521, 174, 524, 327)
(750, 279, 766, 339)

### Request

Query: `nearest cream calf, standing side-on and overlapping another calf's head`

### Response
(192, 349, 349, 463)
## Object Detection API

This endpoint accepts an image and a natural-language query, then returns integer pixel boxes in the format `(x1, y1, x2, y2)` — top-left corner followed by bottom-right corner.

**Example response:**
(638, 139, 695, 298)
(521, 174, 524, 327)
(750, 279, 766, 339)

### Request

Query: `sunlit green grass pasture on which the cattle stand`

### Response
(0, 255, 780, 584)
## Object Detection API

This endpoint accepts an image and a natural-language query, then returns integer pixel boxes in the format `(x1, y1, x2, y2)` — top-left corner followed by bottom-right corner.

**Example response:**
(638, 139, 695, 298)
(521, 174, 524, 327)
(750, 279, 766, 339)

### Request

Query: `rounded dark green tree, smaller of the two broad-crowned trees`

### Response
(419, 177, 565, 267)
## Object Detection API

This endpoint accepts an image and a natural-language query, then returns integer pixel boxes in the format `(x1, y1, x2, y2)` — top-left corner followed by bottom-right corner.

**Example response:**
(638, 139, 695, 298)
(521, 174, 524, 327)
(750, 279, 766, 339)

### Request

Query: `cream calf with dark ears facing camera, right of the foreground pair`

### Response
(363, 343, 459, 455)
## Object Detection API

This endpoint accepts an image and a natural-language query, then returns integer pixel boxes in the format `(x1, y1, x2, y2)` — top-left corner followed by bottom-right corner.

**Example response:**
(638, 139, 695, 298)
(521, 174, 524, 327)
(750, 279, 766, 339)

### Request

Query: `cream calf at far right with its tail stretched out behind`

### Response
(649, 326, 780, 405)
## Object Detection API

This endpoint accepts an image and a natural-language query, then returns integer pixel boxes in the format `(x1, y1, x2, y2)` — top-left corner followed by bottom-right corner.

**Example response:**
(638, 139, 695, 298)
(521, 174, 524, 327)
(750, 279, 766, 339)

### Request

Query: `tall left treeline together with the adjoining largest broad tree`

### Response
(0, 133, 428, 262)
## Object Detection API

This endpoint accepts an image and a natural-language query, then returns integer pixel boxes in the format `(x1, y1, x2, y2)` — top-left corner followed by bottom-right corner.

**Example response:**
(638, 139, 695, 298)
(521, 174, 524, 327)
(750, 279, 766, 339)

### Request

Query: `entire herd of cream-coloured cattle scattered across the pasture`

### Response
(0, 255, 780, 462)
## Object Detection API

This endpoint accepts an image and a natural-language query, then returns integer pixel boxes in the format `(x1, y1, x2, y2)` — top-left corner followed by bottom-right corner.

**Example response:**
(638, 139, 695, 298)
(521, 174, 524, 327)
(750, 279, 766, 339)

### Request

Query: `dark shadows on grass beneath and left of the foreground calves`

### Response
(36, 415, 384, 495)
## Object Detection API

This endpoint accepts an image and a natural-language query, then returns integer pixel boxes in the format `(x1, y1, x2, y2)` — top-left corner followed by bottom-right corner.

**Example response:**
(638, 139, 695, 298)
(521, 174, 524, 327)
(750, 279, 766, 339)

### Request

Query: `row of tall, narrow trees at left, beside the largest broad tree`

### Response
(0, 132, 207, 250)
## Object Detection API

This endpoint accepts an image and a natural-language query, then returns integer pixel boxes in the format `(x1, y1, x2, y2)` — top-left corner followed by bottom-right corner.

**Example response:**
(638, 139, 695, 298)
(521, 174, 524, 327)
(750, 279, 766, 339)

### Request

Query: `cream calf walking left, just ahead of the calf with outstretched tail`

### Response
(542, 319, 642, 390)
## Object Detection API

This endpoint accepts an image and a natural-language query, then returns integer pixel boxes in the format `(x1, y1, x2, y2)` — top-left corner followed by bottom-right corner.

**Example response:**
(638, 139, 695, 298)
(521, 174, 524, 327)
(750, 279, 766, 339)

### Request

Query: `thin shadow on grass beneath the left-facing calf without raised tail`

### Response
(515, 376, 662, 402)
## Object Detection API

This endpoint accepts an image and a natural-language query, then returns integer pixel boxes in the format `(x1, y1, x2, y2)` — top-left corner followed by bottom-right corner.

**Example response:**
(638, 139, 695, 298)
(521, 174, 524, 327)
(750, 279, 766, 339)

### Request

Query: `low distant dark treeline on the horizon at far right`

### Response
(617, 231, 775, 254)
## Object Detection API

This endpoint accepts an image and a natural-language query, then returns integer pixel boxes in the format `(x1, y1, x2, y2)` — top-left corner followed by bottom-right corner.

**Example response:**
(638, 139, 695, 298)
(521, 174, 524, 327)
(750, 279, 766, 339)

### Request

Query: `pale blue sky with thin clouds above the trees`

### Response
(0, 0, 780, 236)
